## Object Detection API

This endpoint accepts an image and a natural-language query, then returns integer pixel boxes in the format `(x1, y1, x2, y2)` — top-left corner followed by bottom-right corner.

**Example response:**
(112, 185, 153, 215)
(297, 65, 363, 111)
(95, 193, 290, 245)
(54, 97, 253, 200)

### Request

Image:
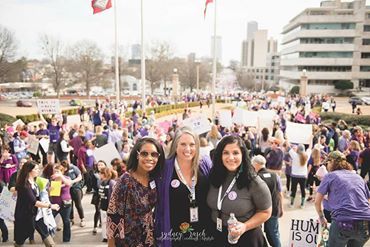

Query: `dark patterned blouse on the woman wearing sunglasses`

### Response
(107, 173, 157, 247)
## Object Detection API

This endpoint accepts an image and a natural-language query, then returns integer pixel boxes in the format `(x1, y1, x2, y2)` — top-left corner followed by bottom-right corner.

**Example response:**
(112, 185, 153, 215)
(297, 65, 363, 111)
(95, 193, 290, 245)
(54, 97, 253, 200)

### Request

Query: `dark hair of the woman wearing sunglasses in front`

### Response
(127, 137, 165, 178)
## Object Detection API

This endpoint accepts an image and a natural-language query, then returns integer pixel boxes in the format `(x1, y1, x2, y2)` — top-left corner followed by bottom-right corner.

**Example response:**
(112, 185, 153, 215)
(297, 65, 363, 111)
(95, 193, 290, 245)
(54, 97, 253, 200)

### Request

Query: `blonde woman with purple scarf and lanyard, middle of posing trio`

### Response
(155, 127, 212, 247)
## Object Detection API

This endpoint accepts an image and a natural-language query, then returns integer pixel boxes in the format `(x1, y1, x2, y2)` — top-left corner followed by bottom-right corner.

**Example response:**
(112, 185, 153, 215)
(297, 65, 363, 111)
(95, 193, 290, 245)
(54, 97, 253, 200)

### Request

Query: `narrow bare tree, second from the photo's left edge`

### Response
(40, 34, 65, 98)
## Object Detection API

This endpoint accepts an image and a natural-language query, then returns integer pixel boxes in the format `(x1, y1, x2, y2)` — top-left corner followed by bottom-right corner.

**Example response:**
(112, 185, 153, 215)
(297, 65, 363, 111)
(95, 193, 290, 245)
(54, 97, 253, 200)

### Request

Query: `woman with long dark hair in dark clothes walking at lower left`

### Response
(14, 161, 59, 246)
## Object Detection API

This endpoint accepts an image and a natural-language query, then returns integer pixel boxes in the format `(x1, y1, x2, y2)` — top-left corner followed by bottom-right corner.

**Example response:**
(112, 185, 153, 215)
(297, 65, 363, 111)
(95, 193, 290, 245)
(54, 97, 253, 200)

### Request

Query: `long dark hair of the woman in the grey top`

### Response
(209, 135, 256, 189)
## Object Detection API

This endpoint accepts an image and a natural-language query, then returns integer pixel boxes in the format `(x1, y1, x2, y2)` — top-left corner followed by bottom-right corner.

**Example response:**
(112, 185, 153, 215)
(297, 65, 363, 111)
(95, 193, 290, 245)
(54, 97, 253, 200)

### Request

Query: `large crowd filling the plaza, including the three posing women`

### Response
(0, 93, 370, 247)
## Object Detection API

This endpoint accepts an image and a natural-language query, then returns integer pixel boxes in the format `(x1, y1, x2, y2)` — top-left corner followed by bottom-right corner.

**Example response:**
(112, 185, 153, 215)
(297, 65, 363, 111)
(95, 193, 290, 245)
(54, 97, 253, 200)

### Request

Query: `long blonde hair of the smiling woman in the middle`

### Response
(168, 126, 200, 176)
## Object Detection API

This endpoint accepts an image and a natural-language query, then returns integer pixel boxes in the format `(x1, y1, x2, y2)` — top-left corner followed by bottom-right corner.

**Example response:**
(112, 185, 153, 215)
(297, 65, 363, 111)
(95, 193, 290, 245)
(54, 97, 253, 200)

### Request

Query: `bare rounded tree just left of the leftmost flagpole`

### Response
(72, 40, 103, 98)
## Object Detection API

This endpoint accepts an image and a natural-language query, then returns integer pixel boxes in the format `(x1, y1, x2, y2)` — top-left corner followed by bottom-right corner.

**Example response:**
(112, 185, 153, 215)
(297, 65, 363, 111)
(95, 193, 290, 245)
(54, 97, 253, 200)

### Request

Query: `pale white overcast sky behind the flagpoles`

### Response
(0, 0, 362, 65)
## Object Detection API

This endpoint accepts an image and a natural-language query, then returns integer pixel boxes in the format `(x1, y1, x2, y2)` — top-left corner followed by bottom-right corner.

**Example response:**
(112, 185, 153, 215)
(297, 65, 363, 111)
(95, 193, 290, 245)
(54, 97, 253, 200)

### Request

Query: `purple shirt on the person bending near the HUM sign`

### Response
(317, 170, 370, 221)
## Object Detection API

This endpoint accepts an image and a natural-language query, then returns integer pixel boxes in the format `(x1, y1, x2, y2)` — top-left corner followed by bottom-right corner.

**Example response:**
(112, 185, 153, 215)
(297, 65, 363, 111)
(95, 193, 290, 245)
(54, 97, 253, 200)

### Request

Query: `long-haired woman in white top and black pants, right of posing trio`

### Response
(289, 144, 309, 208)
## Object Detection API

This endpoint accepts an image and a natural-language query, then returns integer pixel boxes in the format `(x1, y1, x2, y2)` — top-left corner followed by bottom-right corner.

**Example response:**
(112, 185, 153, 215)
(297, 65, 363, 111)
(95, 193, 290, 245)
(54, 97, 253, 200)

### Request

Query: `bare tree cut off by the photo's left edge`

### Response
(0, 25, 17, 82)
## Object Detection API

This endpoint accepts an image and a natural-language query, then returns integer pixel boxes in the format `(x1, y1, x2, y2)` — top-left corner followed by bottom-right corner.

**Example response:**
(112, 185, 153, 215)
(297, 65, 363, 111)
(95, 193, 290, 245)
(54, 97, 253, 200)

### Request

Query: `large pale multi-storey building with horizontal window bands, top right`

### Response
(279, 0, 370, 93)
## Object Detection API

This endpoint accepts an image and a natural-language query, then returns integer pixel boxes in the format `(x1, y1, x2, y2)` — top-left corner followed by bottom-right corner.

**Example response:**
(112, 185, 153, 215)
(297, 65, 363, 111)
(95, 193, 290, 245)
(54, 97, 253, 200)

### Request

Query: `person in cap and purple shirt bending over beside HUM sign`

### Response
(315, 151, 370, 247)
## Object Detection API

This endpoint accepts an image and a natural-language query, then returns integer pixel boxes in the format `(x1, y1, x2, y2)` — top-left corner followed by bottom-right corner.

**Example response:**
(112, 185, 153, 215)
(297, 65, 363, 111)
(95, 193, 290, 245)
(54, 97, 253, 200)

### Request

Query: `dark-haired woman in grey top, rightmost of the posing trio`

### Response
(207, 135, 272, 247)
